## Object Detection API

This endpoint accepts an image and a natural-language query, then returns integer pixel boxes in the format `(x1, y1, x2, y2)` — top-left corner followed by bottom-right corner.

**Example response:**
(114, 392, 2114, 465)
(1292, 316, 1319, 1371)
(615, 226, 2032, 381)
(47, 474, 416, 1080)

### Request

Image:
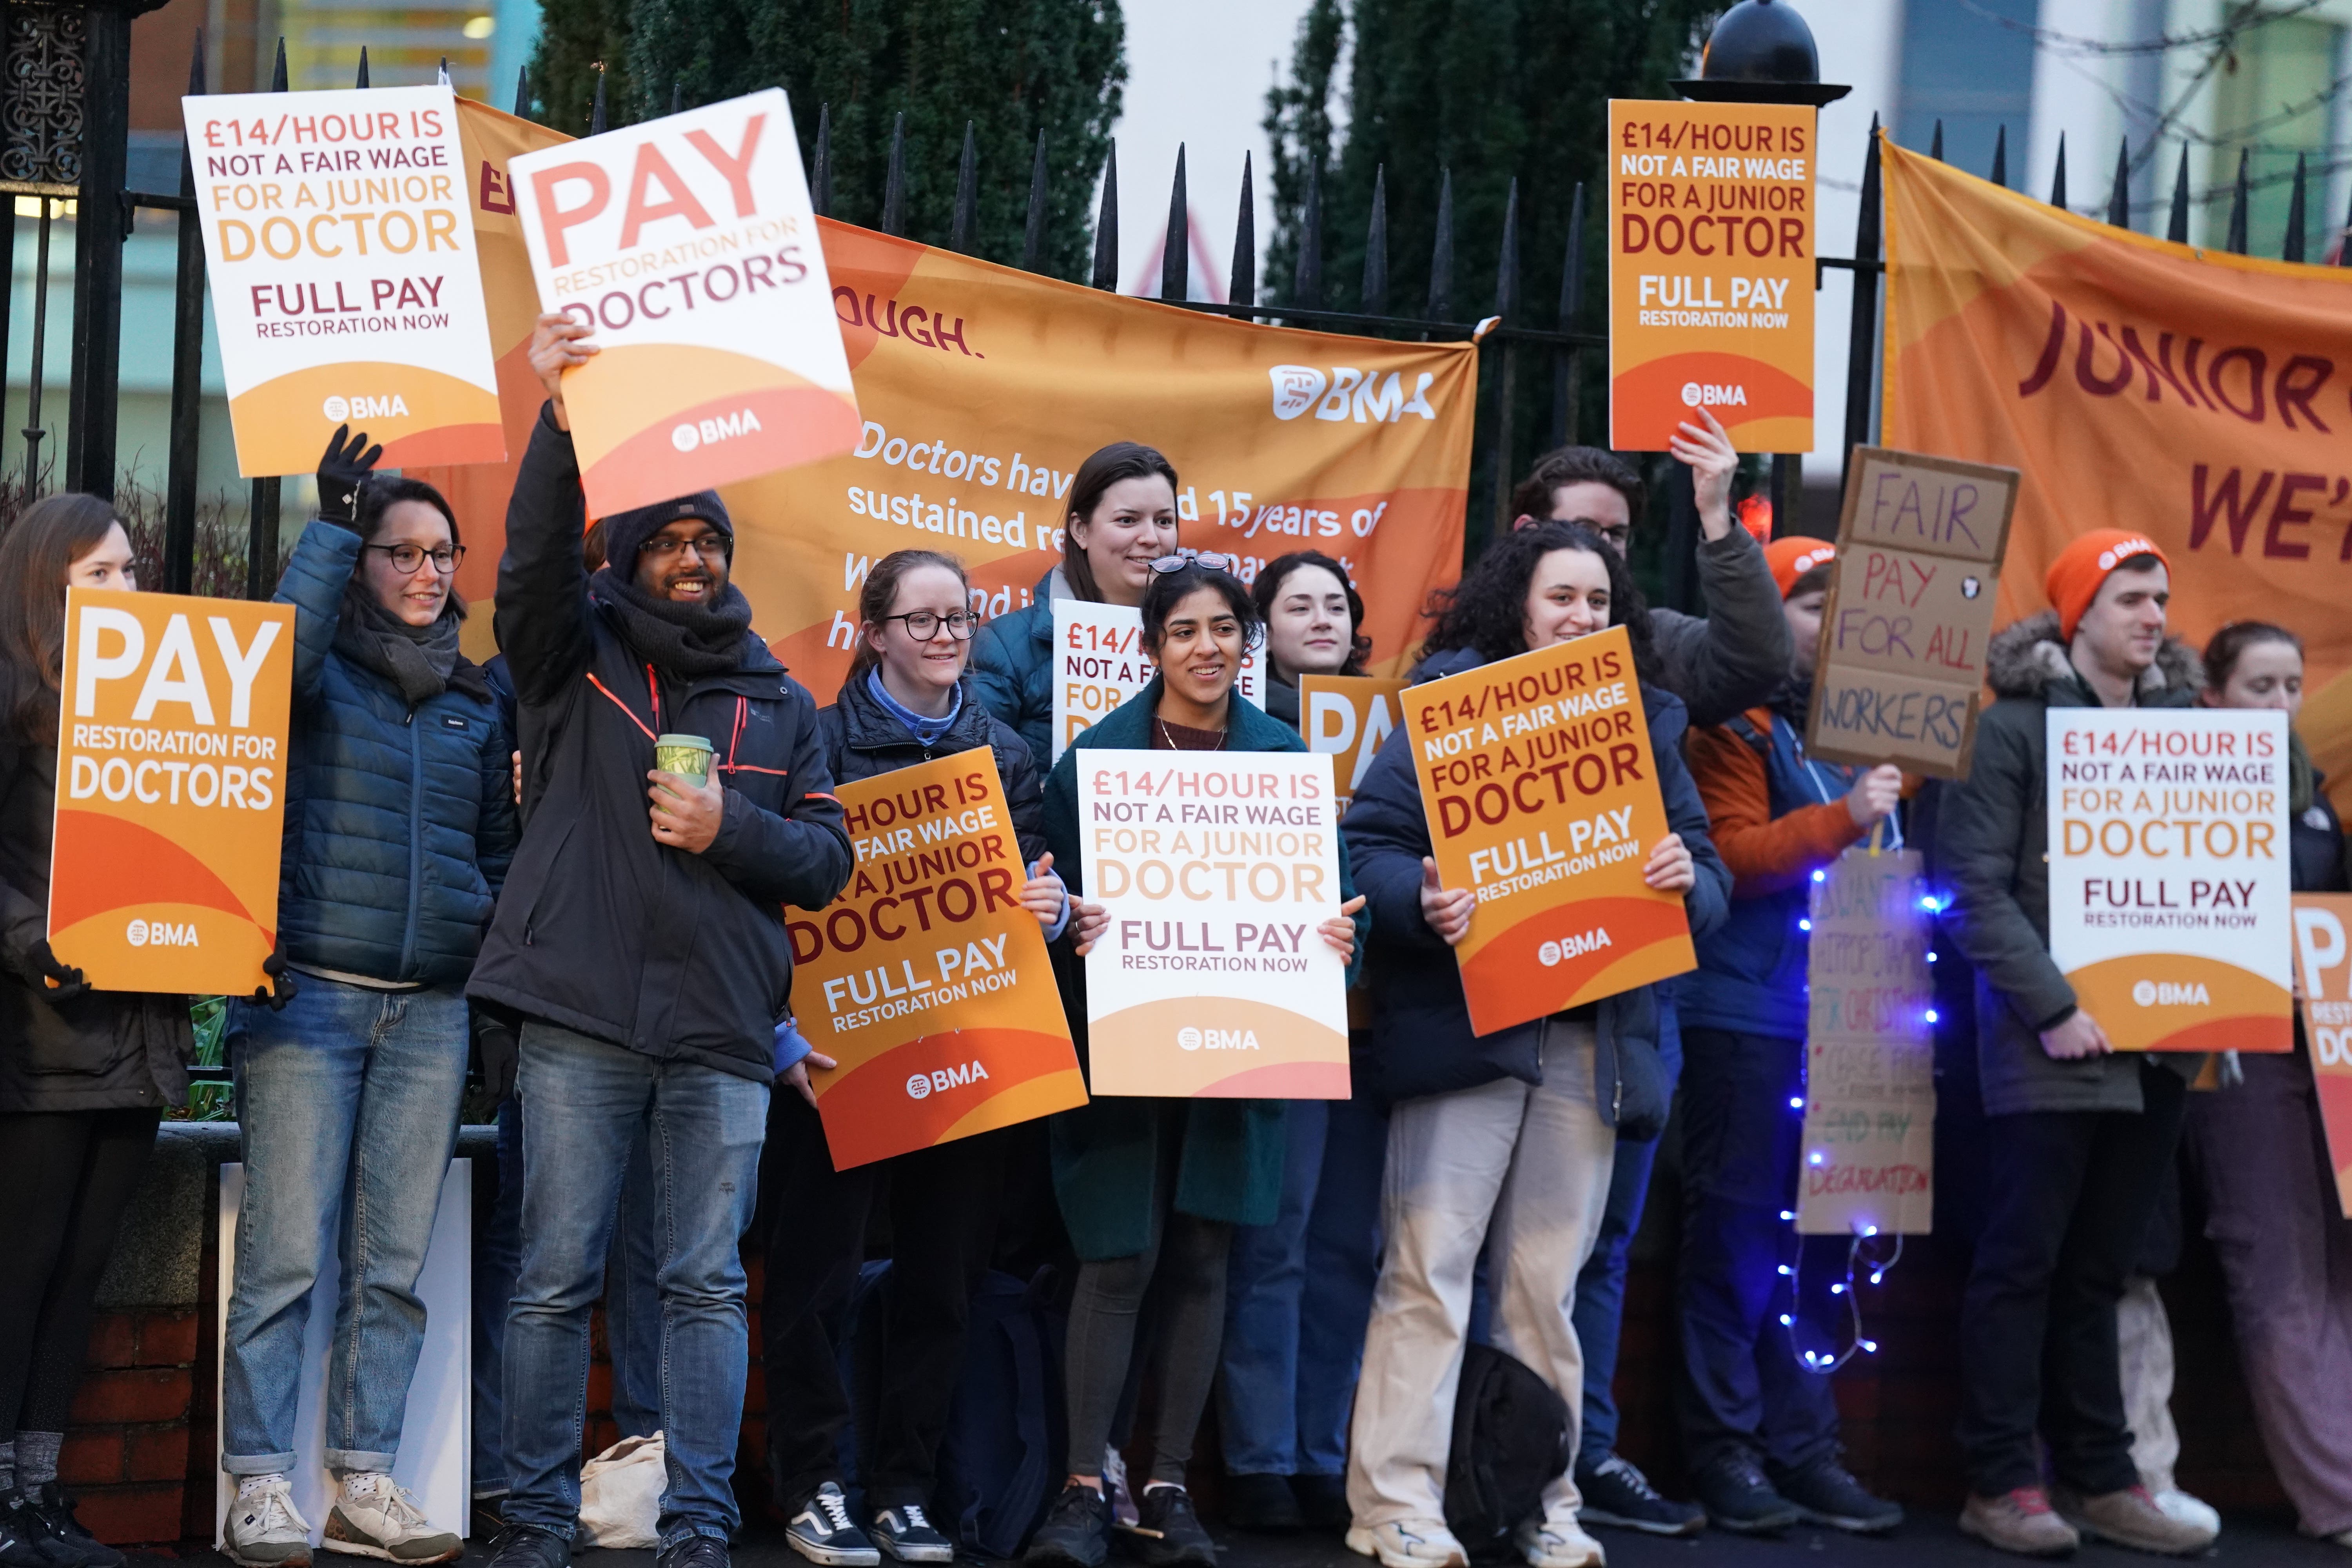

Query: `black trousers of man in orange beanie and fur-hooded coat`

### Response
(1959, 1060, 2187, 1497)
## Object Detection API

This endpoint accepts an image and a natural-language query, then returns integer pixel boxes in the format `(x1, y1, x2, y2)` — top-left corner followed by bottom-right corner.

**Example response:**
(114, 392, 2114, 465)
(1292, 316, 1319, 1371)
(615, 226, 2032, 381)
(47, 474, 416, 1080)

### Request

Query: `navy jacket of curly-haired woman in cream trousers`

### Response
(1341, 649, 1731, 1136)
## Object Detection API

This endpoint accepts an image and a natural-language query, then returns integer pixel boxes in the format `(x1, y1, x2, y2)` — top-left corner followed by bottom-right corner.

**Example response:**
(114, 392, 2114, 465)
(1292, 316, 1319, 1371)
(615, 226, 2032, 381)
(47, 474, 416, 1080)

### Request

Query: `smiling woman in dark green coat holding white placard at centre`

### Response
(1028, 555, 1367, 1568)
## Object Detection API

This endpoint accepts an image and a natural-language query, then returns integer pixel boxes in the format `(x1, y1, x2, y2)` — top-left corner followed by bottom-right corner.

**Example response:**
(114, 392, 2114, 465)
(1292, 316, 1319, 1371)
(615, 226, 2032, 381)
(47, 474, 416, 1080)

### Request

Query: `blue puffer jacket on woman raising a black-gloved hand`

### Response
(278, 519, 517, 985)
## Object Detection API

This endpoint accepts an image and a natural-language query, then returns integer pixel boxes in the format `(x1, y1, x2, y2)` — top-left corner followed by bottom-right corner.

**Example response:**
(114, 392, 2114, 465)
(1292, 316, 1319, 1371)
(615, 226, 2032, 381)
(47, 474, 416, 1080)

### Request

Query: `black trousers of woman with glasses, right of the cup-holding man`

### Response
(760, 1084, 1002, 1509)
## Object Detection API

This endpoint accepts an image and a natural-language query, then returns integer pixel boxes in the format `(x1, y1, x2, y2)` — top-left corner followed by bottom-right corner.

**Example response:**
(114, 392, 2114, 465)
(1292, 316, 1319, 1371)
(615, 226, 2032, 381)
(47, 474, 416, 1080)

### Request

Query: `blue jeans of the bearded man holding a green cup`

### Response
(506, 1020, 767, 1552)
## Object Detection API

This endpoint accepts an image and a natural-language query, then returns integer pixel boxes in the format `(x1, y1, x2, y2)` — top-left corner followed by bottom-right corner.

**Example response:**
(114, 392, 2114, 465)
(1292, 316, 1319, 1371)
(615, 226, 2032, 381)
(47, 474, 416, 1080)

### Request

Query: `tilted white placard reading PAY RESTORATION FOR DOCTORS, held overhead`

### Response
(506, 87, 858, 515)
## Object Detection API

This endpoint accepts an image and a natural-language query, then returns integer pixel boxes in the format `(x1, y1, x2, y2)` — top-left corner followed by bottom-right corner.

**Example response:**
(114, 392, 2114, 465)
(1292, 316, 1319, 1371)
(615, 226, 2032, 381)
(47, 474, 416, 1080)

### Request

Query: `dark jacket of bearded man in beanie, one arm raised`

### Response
(468, 409, 851, 1084)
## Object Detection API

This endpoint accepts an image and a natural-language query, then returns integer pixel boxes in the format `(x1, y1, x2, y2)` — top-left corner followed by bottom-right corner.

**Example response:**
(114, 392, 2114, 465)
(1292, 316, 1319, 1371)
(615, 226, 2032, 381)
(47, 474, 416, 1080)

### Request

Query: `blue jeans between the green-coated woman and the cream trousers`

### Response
(1218, 1096, 1388, 1476)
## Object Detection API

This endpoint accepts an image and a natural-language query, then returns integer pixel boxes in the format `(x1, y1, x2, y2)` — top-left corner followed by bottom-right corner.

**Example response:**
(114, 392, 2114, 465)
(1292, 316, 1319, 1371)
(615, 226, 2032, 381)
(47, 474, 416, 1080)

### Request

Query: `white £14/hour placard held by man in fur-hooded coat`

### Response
(2046, 708, 2296, 1051)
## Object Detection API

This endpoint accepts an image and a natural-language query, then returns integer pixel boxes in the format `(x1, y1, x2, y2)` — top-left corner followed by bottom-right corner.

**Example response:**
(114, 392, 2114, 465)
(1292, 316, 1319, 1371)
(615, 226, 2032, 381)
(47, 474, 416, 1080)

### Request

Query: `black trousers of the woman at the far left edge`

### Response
(0, 1107, 162, 1443)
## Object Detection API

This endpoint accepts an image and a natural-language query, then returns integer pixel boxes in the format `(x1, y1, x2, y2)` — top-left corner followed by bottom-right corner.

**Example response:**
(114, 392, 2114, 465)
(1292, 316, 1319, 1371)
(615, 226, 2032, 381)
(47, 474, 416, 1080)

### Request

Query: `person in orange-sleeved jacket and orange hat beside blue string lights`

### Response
(1679, 538, 1903, 1535)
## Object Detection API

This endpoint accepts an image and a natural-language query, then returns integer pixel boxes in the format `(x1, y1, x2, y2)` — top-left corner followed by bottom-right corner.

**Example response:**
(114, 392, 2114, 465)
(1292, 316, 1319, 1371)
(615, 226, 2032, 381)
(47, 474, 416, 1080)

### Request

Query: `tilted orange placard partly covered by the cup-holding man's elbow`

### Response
(788, 748, 1087, 1171)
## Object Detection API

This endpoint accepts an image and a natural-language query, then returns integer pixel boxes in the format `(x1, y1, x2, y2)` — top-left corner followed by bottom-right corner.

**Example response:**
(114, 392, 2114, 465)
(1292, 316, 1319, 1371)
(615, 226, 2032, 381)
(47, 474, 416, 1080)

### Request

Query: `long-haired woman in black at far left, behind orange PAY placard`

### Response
(0, 494, 195, 1568)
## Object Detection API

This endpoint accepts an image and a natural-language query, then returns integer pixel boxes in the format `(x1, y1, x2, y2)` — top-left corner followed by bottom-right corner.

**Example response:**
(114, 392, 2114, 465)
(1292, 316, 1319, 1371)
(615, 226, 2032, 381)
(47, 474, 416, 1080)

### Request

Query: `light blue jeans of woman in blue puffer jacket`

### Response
(221, 976, 466, 1476)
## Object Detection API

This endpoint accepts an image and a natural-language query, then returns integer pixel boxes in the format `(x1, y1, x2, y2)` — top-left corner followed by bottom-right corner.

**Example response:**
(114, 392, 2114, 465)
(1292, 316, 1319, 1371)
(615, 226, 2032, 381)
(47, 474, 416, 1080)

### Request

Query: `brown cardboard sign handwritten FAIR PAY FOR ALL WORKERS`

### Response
(1804, 446, 2018, 778)
